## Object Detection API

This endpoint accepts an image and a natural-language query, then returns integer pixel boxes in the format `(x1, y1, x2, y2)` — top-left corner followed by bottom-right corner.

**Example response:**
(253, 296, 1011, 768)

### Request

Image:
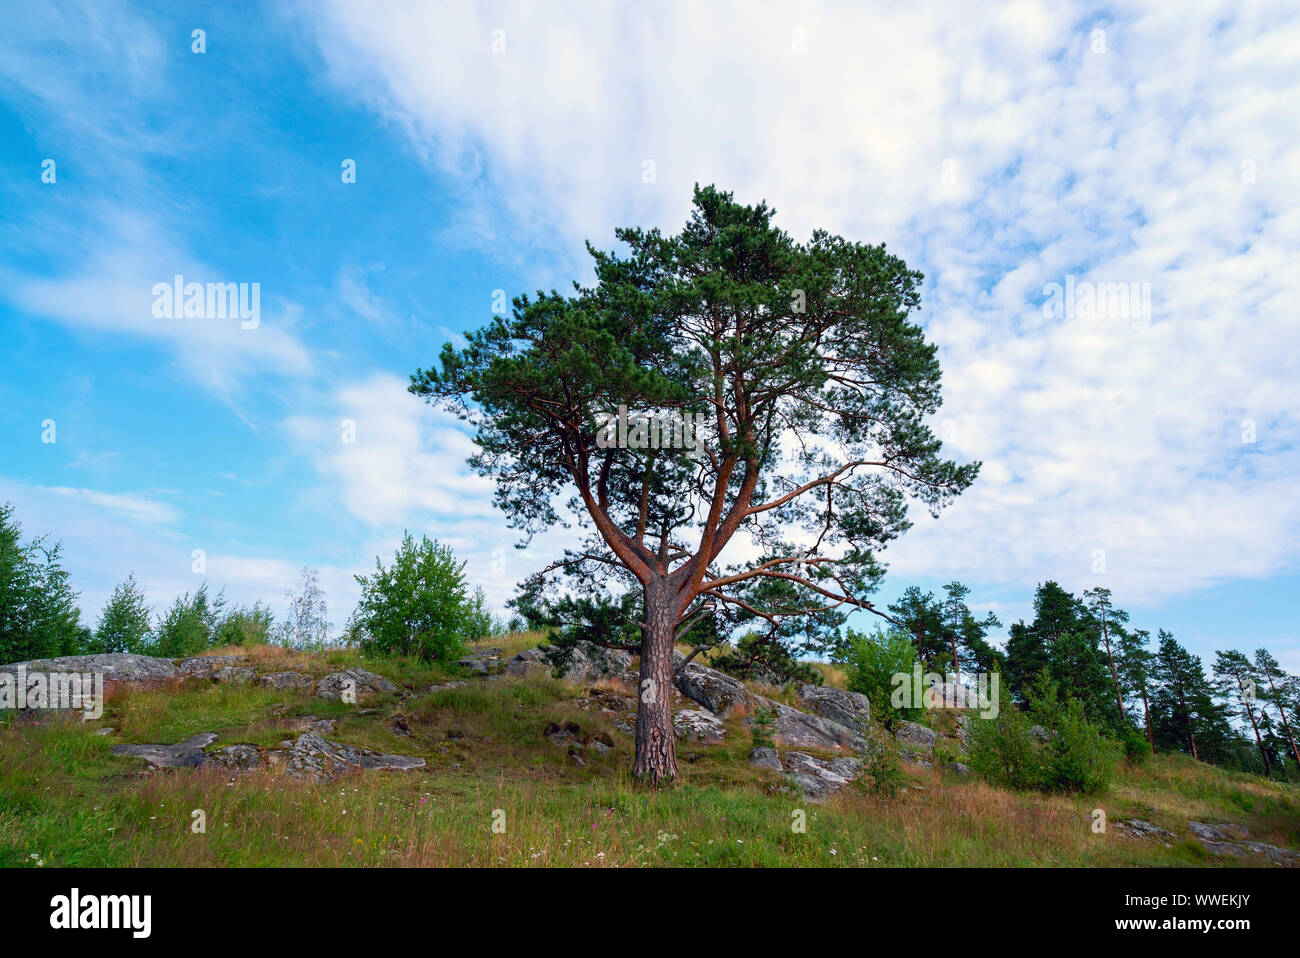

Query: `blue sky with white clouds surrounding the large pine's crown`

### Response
(0, 3, 1300, 669)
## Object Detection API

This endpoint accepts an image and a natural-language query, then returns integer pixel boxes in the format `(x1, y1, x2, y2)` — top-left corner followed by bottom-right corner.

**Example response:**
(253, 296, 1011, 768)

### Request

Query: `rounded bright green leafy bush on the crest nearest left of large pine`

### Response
(348, 533, 482, 662)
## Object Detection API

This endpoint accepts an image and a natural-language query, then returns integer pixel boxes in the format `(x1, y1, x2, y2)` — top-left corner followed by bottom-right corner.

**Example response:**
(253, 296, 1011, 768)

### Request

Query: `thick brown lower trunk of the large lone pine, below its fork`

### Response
(632, 580, 677, 785)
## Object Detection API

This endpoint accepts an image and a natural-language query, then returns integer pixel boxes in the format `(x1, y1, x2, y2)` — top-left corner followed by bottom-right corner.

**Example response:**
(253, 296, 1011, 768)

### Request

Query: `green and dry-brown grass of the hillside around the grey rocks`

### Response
(0, 633, 1300, 867)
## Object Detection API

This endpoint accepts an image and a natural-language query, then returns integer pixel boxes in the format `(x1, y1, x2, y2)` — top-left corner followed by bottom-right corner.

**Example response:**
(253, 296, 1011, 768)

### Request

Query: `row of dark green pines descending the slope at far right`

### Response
(889, 581, 1300, 779)
